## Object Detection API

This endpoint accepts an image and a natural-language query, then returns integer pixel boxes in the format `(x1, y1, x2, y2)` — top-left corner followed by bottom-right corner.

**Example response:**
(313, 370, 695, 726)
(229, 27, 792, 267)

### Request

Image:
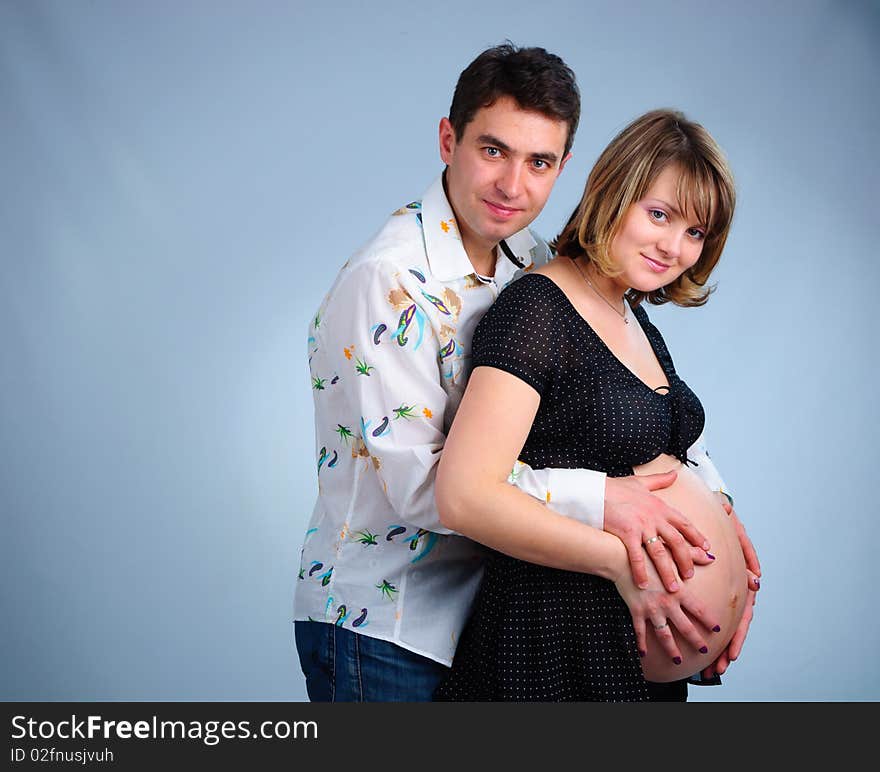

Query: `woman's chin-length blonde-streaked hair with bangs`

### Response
(552, 110, 736, 306)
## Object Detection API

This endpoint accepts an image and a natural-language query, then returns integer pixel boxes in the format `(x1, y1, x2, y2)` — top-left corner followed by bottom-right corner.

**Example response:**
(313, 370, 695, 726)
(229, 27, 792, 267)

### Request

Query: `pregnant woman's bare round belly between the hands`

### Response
(633, 455, 747, 682)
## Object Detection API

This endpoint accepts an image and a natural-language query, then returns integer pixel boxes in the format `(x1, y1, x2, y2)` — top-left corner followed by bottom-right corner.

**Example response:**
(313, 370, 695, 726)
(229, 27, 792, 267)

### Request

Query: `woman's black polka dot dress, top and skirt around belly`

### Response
(434, 274, 704, 702)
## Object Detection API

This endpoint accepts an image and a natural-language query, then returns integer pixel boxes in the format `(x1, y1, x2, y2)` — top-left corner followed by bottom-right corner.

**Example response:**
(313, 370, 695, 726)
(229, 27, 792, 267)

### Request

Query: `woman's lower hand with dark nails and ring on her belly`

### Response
(614, 568, 721, 665)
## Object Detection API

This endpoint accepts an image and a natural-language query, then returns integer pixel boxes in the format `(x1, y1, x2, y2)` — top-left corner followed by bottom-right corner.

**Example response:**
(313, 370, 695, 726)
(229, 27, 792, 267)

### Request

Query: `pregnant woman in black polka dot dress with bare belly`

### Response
(435, 110, 749, 701)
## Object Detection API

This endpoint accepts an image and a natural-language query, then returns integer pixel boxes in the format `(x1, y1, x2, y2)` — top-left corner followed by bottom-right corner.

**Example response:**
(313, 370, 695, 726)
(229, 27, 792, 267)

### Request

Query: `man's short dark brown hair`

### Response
(449, 40, 581, 157)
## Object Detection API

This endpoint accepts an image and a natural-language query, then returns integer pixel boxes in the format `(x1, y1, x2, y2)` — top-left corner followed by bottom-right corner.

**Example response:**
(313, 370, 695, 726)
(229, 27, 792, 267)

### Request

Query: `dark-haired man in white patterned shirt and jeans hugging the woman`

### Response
(295, 45, 747, 701)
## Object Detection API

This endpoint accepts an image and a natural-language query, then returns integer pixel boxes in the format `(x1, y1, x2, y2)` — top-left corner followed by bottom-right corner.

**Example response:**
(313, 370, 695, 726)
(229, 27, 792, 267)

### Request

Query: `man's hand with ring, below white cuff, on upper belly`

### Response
(605, 471, 712, 592)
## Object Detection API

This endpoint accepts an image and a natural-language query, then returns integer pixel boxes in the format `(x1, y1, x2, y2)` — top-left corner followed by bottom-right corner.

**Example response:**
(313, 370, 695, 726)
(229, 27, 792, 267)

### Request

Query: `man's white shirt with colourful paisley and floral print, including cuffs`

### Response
(295, 176, 722, 665)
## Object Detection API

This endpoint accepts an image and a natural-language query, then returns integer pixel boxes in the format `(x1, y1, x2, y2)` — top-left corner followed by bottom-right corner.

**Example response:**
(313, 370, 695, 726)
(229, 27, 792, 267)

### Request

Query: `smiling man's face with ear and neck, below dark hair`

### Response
(440, 97, 571, 261)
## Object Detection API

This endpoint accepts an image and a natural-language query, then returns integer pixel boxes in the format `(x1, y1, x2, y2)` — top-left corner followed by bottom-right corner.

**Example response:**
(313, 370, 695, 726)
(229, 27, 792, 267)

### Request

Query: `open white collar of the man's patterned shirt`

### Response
(422, 174, 538, 281)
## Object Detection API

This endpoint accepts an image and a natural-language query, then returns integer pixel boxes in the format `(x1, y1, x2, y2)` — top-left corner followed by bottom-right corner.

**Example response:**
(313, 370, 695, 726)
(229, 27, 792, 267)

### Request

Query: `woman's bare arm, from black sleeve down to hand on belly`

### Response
(435, 367, 718, 659)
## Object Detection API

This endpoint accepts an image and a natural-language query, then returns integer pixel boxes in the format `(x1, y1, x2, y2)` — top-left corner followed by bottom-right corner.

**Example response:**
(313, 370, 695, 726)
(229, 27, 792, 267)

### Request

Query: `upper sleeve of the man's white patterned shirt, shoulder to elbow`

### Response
(316, 261, 452, 534)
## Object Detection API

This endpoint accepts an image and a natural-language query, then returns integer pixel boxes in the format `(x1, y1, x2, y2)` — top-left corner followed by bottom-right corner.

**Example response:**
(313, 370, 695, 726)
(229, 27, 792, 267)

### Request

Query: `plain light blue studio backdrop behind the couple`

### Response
(0, 0, 880, 701)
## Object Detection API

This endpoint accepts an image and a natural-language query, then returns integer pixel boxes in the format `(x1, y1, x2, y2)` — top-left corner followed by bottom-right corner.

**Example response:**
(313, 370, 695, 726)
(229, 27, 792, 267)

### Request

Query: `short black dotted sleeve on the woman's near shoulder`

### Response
(472, 274, 560, 395)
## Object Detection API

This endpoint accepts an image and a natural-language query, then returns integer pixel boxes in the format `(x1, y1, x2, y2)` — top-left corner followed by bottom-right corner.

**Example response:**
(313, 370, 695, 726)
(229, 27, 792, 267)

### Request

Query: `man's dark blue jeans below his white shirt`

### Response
(294, 622, 449, 702)
